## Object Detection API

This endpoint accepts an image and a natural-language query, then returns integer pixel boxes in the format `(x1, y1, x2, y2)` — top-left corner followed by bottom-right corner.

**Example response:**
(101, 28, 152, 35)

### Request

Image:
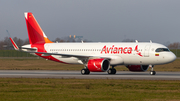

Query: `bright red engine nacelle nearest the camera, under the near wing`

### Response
(87, 59, 110, 72)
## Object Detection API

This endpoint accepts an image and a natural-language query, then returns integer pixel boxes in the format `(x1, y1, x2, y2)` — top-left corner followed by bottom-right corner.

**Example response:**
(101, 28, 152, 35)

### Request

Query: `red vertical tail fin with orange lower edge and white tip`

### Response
(24, 12, 53, 44)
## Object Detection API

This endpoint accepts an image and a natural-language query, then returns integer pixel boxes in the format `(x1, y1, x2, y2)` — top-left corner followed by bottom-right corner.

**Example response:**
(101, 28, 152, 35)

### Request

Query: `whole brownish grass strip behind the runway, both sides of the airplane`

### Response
(0, 59, 180, 71)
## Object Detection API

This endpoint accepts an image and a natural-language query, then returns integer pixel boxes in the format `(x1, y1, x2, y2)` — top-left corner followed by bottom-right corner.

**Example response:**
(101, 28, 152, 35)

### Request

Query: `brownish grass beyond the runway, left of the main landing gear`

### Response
(0, 59, 83, 70)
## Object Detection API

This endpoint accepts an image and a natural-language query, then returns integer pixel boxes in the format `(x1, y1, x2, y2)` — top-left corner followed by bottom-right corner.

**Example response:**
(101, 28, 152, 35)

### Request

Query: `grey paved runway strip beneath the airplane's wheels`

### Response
(0, 70, 180, 80)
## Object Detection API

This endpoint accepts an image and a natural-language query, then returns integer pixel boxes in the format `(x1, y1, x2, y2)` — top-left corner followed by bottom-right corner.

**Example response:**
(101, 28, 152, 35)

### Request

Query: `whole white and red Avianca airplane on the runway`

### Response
(10, 12, 176, 75)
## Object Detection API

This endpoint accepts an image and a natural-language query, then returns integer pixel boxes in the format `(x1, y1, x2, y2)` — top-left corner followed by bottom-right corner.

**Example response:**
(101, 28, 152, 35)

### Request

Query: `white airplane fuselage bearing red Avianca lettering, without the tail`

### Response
(31, 42, 176, 65)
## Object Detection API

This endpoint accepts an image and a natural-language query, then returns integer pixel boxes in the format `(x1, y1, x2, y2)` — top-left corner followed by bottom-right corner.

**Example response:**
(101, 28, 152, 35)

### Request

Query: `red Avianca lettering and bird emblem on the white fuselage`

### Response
(101, 45, 142, 57)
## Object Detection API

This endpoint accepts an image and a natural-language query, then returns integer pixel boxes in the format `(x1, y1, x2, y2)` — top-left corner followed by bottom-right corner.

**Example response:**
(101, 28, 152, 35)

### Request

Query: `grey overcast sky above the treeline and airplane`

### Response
(0, 0, 180, 44)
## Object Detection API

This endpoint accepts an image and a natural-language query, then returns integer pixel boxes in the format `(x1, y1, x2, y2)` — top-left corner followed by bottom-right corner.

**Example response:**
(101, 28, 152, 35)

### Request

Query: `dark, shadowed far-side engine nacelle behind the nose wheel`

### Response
(126, 65, 149, 72)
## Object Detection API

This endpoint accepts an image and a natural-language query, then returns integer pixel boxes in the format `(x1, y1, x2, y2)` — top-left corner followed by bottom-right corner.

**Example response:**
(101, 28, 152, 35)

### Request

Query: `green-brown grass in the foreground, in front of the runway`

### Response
(0, 78, 180, 101)
